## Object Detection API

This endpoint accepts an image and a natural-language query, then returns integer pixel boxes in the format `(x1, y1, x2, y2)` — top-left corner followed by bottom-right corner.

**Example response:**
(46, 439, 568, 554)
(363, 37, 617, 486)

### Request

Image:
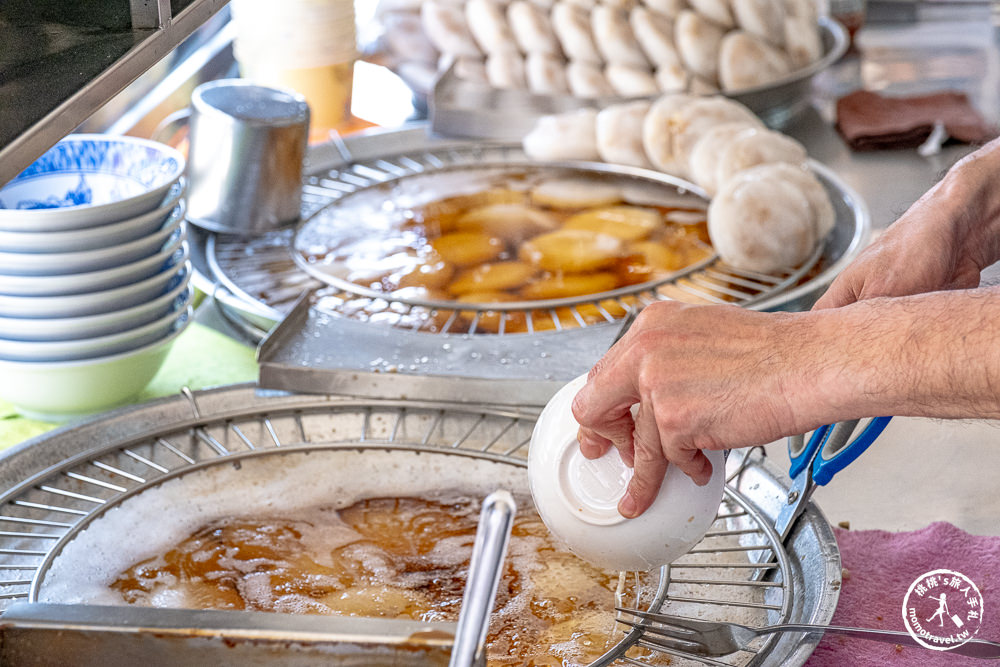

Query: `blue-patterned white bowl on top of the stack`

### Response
(0, 134, 184, 232)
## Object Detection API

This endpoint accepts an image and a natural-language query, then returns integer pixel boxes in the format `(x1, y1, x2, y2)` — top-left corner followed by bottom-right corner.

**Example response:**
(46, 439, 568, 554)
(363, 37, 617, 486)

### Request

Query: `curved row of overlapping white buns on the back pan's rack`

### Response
(524, 93, 835, 274)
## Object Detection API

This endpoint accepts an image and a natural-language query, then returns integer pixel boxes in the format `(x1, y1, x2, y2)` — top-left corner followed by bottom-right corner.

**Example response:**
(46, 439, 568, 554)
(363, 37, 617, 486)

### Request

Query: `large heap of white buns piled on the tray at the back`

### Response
(374, 0, 823, 99)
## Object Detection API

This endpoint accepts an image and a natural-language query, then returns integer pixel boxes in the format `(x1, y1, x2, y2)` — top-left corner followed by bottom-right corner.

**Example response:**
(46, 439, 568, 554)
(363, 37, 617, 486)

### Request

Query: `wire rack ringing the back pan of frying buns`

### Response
(206, 144, 822, 335)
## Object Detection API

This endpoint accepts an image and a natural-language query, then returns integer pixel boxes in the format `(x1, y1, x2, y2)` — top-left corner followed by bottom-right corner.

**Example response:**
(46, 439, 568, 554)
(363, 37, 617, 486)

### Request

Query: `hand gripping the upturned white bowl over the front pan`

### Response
(573, 302, 824, 517)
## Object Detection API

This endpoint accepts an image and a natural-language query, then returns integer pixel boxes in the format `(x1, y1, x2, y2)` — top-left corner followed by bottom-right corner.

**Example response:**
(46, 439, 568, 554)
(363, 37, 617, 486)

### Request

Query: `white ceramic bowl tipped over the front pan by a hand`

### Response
(528, 376, 726, 571)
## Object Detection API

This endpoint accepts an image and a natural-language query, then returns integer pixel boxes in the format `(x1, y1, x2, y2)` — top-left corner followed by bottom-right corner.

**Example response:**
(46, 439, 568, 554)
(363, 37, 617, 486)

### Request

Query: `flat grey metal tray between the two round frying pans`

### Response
(257, 295, 622, 405)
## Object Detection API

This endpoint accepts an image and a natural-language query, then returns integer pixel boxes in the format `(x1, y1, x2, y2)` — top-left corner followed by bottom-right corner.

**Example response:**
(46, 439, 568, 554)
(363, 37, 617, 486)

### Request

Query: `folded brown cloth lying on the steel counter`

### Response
(837, 90, 997, 151)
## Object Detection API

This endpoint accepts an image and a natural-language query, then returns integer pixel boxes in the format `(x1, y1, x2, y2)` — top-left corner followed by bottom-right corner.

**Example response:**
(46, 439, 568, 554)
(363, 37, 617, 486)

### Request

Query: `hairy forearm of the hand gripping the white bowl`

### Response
(791, 288, 1000, 423)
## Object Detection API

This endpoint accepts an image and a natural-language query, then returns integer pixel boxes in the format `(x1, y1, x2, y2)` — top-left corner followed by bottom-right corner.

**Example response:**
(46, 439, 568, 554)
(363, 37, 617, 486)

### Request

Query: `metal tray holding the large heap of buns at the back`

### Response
(430, 17, 848, 141)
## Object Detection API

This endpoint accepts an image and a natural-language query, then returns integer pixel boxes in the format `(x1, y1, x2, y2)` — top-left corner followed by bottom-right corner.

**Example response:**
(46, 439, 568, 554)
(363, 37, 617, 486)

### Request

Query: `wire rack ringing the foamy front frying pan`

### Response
(0, 394, 793, 667)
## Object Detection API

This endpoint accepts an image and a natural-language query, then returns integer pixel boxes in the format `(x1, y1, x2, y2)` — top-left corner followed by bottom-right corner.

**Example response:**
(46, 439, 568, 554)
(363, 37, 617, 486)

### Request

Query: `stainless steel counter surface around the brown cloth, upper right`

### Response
(784, 4, 1000, 229)
